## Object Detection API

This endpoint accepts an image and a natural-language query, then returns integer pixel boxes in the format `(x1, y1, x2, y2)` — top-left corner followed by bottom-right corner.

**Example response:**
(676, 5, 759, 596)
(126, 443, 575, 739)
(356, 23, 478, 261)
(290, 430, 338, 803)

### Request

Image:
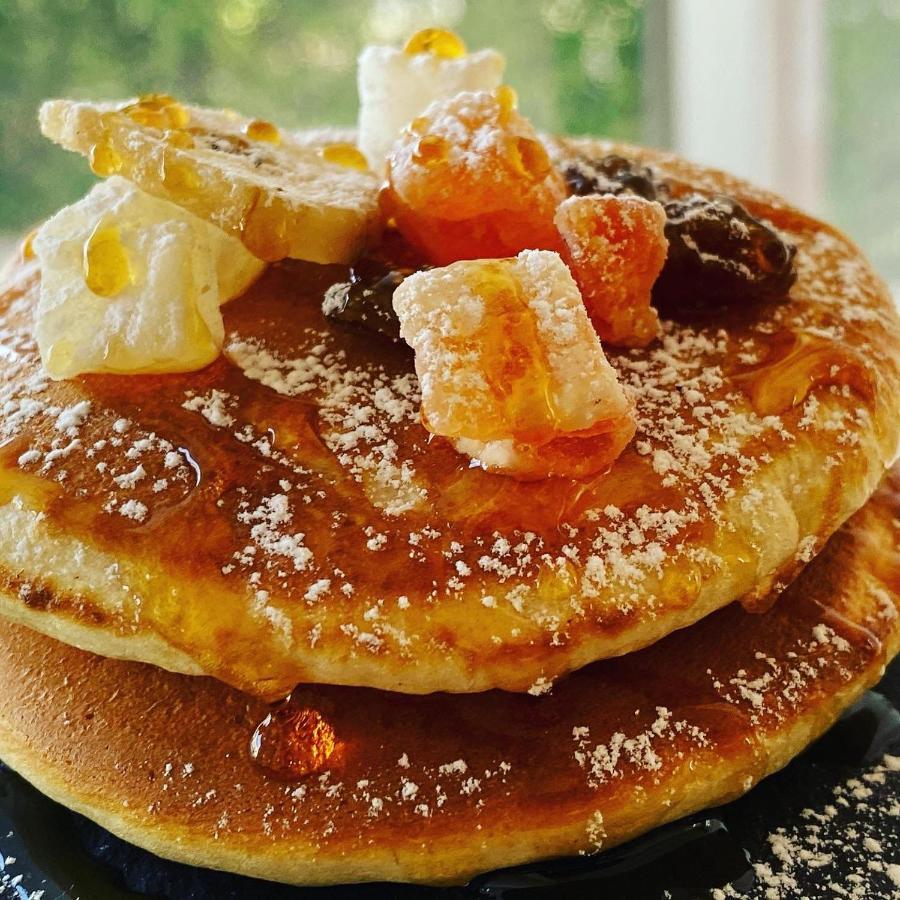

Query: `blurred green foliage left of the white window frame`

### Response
(0, 0, 643, 233)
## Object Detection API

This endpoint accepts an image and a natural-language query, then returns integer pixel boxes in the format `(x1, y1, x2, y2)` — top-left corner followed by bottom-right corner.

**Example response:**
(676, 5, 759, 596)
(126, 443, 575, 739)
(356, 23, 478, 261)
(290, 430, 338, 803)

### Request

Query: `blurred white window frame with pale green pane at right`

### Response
(668, 0, 900, 297)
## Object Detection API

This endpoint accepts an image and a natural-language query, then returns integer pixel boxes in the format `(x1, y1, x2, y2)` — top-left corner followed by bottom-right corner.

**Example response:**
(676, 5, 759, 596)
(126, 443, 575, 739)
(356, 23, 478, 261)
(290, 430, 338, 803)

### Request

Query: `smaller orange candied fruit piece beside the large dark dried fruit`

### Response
(556, 194, 668, 347)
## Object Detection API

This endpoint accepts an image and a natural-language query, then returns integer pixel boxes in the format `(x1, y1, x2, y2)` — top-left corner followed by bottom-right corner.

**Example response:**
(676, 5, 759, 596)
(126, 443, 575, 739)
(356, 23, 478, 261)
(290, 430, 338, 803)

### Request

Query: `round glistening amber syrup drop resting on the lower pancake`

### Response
(250, 698, 337, 781)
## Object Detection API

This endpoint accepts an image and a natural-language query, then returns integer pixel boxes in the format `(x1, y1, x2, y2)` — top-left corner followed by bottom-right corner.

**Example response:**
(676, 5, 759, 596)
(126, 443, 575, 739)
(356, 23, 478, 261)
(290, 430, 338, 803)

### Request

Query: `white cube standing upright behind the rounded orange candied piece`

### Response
(357, 39, 506, 172)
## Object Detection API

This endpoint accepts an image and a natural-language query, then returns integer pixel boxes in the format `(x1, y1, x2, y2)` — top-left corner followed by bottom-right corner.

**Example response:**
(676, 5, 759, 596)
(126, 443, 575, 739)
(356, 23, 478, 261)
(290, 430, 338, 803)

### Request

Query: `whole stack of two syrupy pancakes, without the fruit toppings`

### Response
(0, 141, 900, 884)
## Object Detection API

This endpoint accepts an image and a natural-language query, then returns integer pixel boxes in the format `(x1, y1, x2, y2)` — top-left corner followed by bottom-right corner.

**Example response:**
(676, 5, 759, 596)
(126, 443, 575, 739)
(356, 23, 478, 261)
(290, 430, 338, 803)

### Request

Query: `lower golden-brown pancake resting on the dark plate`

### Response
(0, 471, 900, 884)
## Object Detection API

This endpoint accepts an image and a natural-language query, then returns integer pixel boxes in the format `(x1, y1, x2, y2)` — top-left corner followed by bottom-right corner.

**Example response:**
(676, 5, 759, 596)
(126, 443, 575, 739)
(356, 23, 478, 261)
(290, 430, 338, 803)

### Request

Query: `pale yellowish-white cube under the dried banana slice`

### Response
(34, 177, 265, 379)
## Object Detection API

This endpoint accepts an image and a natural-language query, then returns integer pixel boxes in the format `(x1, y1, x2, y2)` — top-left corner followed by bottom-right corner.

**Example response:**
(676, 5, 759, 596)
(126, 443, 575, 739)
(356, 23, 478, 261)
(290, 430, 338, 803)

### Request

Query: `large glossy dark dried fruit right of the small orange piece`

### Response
(653, 194, 796, 312)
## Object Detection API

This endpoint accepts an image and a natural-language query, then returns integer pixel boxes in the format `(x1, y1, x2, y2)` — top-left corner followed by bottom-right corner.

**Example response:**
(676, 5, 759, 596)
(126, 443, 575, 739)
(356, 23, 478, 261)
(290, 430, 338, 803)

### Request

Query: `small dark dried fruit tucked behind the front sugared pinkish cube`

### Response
(322, 258, 417, 341)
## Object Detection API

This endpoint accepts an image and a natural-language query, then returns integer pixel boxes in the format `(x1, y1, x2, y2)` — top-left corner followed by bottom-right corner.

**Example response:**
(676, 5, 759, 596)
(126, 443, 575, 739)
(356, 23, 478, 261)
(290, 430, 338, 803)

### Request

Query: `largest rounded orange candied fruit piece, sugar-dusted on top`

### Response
(382, 86, 566, 265)
